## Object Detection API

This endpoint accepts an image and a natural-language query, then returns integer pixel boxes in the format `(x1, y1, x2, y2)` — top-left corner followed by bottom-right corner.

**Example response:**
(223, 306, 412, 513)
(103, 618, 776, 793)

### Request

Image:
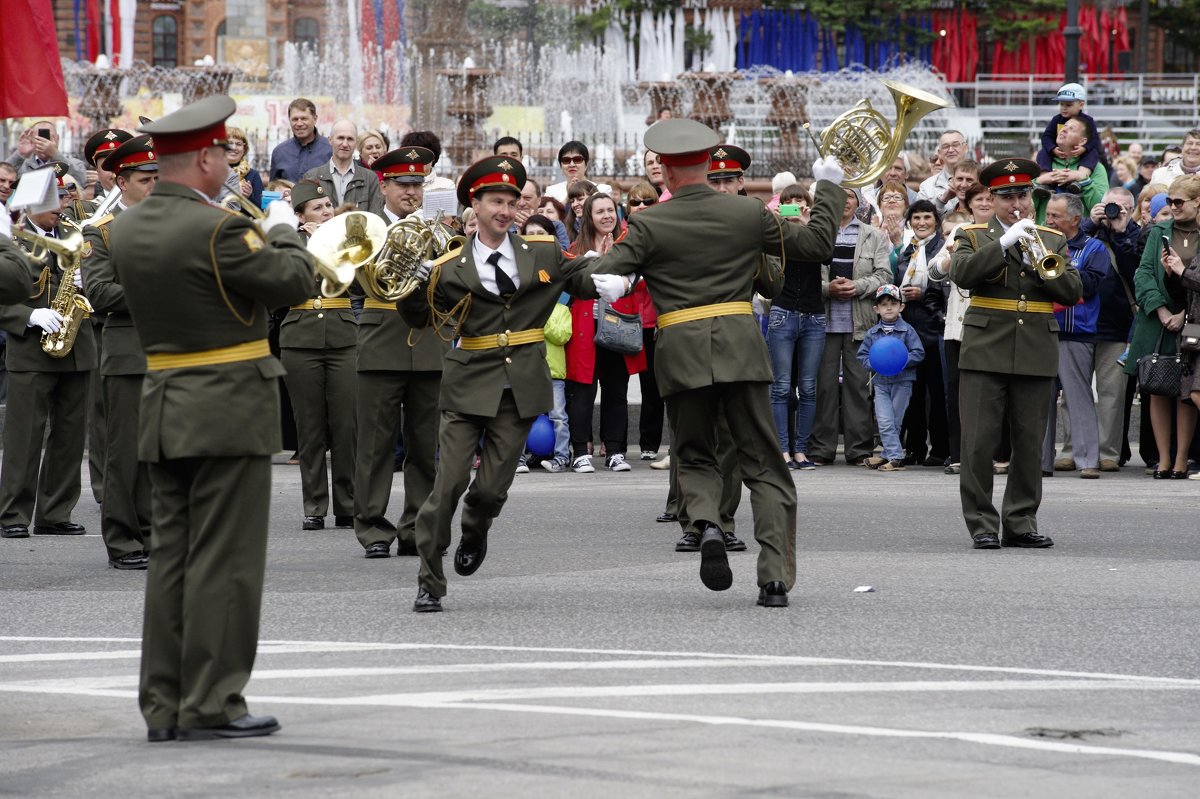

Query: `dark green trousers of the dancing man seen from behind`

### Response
(666, 382, 796, 590)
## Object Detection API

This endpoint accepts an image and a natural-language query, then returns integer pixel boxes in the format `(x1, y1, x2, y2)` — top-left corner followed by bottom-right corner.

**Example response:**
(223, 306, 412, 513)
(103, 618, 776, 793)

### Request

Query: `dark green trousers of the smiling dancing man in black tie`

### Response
(416, 389, 536, 596)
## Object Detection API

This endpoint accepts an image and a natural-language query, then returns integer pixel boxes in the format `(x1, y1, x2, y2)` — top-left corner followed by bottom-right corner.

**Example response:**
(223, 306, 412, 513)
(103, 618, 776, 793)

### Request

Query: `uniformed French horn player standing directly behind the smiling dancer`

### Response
(354, 146, 453, 558)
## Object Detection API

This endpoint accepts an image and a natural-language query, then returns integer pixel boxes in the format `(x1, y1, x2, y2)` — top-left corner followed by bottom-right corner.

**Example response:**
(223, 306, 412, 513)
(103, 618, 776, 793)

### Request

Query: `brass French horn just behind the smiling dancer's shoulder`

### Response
(359, 211, 456, 302)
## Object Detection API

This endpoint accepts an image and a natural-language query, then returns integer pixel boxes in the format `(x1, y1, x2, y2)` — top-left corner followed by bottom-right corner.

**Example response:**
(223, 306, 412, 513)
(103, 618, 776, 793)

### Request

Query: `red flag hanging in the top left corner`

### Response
(0, 0, 67, 119)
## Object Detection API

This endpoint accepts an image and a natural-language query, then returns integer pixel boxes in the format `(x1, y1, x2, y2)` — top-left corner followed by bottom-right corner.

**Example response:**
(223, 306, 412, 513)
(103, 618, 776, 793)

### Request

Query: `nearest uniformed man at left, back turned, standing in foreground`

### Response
(112, 95, 313, 741)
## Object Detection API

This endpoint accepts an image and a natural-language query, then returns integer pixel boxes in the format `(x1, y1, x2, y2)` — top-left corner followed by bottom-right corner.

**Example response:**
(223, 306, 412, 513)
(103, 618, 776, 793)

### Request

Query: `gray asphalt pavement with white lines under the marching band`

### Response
(0, 462, 1200, 798)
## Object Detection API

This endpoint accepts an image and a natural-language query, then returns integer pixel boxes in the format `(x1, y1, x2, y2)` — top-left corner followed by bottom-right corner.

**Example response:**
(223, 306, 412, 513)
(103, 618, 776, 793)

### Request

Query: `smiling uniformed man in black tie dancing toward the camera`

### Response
(400, 156, 633, 613)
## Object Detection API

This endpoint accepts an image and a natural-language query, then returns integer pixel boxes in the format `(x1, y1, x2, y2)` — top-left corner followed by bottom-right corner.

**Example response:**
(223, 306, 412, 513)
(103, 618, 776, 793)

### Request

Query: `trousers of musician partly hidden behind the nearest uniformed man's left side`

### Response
(100, 374, 151, 559)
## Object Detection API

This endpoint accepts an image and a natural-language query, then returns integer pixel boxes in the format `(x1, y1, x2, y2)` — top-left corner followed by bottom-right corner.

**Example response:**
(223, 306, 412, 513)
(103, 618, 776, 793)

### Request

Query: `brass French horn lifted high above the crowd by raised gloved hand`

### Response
(804, 80, 949, 188)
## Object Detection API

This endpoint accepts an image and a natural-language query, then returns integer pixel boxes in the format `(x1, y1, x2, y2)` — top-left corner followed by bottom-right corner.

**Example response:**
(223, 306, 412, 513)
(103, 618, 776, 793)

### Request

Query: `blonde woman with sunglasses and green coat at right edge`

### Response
(1126, 175, 1200, 472)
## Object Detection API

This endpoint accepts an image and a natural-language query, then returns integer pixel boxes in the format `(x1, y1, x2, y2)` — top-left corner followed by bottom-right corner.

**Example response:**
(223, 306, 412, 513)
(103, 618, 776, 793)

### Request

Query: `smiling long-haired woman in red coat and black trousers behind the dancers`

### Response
(566, 194, 646, 474)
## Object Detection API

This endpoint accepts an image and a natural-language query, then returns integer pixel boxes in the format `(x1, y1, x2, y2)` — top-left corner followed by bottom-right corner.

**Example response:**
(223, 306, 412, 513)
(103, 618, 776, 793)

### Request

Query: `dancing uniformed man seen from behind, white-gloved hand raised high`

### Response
(580, 119, 845, 607)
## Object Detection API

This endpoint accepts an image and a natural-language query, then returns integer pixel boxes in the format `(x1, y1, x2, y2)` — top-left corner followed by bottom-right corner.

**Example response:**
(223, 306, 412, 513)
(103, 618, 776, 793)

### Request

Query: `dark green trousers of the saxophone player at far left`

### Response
(0, 372, 90, 527)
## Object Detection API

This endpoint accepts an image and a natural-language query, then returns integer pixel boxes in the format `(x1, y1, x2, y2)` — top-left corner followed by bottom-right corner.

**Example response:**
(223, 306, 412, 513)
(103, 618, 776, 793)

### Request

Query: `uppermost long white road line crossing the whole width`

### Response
(0, 636, 1200, 685)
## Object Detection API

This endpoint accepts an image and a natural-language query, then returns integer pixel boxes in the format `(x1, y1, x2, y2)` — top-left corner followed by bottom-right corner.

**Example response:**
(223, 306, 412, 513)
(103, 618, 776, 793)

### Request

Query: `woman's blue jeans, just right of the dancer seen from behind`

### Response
(767, 308, 826, 452)
